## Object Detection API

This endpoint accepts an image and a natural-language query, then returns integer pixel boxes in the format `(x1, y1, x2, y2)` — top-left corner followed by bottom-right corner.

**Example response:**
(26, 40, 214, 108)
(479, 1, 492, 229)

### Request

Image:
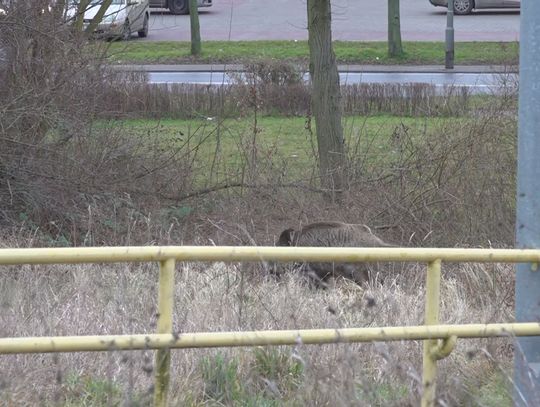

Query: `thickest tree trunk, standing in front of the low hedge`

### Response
(307, 0, 346, 199)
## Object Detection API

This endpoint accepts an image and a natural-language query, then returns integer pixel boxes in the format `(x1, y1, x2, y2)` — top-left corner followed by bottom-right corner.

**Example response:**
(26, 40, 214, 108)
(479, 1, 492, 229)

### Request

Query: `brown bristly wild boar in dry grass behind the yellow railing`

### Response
(277, 222, 391, 286)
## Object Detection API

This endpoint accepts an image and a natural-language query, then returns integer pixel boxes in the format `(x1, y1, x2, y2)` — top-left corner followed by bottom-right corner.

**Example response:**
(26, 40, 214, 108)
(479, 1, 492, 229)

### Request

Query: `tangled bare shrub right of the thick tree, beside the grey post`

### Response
(342, 101, 517, 246)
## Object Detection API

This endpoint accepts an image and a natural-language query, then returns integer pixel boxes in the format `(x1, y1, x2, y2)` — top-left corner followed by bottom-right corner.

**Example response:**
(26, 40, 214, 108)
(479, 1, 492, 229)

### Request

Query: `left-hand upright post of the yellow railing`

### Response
(154, 259, 175, 407)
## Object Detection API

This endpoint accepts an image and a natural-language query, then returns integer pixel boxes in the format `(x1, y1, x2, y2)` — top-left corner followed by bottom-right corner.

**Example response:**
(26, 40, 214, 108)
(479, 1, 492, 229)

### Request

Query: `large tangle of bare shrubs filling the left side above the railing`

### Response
(0, 0, 197, 244)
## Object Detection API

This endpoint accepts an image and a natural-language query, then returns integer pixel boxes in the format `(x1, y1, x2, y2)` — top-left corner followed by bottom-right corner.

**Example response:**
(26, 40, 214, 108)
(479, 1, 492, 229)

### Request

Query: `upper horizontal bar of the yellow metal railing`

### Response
(0, 246, 540, 265)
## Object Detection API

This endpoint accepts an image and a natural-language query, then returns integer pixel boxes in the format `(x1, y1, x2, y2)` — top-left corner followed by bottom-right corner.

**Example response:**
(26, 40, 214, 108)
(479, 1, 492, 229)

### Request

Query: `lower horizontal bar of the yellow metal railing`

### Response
(0, 322, 540, 354)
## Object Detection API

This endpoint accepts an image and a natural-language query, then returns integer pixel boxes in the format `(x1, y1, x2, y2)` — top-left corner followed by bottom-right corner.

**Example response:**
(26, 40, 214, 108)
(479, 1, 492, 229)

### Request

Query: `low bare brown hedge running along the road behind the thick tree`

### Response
(100, 61, 472, 119)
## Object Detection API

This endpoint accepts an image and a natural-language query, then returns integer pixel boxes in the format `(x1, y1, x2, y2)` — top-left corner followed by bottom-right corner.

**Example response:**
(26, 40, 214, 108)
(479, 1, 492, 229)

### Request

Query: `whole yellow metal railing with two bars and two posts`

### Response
(0, 246, 540, 406)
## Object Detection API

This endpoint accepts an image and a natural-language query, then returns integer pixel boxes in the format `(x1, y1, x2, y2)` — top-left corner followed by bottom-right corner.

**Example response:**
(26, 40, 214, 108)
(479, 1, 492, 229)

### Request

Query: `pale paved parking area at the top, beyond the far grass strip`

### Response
(146, 0, 519, 41)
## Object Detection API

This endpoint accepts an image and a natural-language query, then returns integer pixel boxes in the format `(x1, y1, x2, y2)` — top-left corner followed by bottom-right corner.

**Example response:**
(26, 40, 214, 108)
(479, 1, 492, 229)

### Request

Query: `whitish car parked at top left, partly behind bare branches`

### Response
(73, 0, 150, 40)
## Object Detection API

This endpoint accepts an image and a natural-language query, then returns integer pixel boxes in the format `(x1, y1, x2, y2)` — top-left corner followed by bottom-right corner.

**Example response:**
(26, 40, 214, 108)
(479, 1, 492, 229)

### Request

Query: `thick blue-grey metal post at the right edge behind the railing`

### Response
(514, 0, 540, 406)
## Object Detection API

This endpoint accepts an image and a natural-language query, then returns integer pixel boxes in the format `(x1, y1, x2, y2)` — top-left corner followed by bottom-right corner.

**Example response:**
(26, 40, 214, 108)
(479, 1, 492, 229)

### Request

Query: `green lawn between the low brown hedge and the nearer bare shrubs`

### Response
(118, 116, 456, 184)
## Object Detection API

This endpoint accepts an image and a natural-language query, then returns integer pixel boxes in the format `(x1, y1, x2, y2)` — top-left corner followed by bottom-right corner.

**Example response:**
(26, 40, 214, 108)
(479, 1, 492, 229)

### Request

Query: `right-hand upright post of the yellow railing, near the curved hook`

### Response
(421, 260, 441, 407)
